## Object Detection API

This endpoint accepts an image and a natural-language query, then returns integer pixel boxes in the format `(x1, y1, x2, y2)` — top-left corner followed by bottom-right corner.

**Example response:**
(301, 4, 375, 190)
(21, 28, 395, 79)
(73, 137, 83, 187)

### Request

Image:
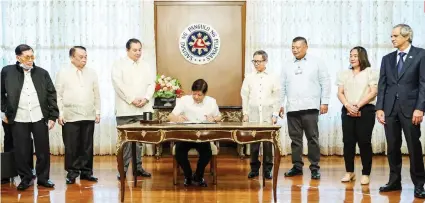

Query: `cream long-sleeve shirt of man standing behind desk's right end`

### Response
(241, 69, 281, 122)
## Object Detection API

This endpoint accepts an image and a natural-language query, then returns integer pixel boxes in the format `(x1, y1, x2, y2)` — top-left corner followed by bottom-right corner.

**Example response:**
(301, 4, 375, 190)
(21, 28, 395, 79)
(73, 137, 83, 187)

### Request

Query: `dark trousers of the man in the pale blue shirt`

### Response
(286, 109, 320, 170)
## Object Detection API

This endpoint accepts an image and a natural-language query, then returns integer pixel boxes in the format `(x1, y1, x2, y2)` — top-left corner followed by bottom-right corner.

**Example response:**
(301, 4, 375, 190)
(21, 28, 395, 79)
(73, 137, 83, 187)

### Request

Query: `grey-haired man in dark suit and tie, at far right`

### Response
(376, 24, 425, 198)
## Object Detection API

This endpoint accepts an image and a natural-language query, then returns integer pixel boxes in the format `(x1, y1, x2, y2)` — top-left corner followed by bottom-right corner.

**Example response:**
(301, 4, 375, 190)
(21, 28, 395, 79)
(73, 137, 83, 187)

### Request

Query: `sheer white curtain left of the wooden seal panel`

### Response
(0, 0, 156, 155)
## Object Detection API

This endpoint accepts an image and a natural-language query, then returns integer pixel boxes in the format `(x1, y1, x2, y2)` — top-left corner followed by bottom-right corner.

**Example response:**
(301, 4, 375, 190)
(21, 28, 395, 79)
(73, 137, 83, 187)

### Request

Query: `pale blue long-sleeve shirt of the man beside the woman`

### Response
(281, 54, 331, 112)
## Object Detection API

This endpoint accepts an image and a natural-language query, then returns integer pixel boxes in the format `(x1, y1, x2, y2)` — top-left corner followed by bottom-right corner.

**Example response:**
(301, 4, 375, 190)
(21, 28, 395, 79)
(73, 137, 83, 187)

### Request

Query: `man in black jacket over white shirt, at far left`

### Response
(1, 44, 59, 190)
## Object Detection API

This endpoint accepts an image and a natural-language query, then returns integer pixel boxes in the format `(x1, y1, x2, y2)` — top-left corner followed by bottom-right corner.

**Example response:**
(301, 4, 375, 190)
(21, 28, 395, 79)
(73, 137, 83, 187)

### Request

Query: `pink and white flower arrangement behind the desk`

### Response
(153, 75, 183, 98)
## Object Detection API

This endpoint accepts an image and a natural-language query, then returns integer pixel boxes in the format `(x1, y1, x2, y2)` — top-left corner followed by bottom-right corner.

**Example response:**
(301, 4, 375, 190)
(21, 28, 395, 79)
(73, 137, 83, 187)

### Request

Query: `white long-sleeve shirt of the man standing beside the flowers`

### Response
(112, 56, 156, 116)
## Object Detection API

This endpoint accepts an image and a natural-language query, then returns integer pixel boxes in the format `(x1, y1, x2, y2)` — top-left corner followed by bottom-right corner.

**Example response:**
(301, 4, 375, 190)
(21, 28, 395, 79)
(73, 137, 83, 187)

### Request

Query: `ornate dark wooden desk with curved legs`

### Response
(117, 122, 282, 202)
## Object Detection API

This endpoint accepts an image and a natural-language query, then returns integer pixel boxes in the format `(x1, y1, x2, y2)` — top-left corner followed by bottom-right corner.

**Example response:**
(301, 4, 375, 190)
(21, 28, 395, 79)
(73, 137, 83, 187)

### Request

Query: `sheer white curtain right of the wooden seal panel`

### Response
(245, 0, 425, 155)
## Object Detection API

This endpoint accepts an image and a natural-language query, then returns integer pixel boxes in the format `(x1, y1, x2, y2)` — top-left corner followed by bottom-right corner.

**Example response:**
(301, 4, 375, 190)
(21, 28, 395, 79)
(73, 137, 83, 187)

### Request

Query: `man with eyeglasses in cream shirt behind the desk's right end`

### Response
(241, 50, 281, 179)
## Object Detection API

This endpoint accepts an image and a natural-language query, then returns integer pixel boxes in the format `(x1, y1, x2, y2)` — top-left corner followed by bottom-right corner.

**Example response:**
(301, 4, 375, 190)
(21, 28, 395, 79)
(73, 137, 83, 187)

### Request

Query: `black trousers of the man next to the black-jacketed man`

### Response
(62, 121, 94, 178)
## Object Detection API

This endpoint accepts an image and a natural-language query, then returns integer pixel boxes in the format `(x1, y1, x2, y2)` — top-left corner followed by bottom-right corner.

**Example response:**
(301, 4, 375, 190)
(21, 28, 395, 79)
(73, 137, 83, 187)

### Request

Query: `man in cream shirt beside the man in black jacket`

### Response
(56, 46, 100, 184)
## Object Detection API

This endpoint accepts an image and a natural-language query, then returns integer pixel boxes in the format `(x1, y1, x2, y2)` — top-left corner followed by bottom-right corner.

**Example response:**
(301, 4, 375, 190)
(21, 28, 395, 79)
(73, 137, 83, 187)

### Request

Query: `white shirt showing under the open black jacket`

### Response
(15, 70, 43, 123)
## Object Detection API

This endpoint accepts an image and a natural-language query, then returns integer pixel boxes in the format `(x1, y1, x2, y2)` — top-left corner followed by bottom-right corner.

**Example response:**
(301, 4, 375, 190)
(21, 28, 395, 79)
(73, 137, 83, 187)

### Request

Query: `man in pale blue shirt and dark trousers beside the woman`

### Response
(280, 37, 331, 179)
